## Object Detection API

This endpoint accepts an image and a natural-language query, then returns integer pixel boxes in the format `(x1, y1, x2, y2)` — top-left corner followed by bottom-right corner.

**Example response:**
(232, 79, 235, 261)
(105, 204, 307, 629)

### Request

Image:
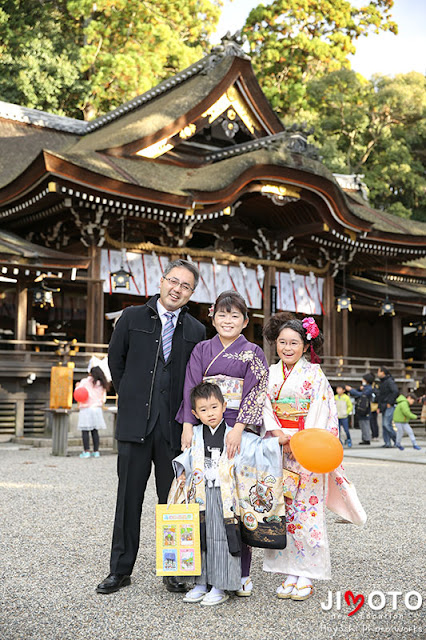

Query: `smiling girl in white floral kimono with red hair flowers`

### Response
(263, 313, 366, 600)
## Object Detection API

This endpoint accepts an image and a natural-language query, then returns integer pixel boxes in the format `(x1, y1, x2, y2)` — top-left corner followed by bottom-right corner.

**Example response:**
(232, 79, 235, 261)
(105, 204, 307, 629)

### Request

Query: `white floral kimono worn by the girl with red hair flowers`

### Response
(263, 357, 367, 580)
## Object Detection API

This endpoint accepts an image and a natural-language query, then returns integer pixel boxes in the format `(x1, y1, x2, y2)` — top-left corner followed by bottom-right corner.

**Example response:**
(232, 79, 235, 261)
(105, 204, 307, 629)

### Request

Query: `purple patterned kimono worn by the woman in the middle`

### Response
(176, 335, 269, 433)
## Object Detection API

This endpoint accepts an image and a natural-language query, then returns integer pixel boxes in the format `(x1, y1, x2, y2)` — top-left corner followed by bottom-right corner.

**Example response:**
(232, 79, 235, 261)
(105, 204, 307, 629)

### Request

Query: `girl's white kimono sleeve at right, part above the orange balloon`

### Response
(305, 365, 339, 436)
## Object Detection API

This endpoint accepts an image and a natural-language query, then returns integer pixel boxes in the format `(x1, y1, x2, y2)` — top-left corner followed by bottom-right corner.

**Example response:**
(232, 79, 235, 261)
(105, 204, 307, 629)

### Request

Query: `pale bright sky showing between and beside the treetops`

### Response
(214, 0, 426, 78)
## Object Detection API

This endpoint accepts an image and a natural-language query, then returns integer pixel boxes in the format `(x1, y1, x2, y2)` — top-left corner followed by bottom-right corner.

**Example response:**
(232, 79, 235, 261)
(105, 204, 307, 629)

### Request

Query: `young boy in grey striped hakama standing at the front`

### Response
(173, 382, 284, 606)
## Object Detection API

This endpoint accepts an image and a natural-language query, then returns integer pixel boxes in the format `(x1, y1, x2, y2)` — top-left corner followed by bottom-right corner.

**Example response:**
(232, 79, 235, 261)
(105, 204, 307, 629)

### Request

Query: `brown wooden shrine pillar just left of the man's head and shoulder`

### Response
(86, 245, 104, 343)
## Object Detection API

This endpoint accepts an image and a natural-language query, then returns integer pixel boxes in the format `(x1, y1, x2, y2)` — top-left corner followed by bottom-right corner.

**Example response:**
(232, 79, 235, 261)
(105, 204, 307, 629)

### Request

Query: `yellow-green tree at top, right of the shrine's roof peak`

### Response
(244, 0, 397, 117)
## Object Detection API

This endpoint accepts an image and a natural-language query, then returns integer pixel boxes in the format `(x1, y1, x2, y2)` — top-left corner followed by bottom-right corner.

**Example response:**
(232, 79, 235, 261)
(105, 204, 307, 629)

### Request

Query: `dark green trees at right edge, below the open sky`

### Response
(307, 69, 426, 220)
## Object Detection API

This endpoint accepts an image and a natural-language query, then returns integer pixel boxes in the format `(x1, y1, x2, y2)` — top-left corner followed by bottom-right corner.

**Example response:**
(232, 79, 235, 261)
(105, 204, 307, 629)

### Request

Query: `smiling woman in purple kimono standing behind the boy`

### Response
(176, 291, 268, 596)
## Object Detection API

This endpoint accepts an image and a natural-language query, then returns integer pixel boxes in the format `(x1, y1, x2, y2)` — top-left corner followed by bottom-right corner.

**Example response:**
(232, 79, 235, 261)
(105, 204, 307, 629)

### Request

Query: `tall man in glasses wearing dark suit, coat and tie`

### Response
(96, 260, 205, 593)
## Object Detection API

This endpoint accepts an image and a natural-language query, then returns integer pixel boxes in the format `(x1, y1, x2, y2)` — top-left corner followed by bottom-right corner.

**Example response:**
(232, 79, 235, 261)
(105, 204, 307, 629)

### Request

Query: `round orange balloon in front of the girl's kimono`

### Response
(290, 429, 343, 473)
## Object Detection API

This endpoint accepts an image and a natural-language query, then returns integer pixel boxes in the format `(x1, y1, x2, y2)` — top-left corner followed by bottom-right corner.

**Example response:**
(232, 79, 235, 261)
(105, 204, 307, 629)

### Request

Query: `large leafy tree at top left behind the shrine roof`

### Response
(0, 0, 222, 120)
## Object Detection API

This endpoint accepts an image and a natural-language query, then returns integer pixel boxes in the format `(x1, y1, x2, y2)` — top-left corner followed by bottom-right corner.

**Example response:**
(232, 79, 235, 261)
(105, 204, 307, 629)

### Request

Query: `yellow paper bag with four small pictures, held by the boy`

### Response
(155, 504, 201, 577)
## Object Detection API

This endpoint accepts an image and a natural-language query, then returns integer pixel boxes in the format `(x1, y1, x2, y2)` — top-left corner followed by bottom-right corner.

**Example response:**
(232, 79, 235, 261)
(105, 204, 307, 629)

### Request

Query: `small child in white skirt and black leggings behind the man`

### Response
(75, 367, 109, 458)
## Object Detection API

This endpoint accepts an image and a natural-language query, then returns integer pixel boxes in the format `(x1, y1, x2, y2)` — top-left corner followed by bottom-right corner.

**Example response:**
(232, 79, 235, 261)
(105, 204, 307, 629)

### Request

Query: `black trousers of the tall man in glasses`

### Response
(110, 423, 180, 575)
